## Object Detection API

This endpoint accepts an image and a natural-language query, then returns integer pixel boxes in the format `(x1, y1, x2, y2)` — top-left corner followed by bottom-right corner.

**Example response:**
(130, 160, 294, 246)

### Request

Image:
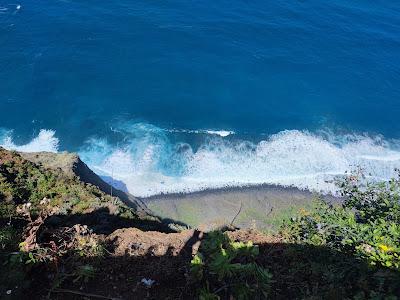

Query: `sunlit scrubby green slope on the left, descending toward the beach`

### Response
(0, 148, 135, 219)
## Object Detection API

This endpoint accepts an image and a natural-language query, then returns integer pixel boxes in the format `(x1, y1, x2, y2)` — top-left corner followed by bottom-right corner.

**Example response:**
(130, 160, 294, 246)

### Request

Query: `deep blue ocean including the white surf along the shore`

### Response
(0, 0, 400, 196)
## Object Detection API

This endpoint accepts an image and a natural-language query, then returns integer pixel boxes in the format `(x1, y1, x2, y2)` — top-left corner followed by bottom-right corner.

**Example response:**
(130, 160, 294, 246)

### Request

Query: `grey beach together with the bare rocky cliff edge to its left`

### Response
(16, 148, 341, 231)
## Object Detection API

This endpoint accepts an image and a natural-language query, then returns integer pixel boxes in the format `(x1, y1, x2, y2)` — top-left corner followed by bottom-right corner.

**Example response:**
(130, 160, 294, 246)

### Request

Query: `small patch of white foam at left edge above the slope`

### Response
(0, 129, 59, 152)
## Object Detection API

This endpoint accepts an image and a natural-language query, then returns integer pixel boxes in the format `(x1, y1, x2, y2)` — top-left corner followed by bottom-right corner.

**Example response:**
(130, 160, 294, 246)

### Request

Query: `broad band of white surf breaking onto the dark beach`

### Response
(77, 124, 400, 197)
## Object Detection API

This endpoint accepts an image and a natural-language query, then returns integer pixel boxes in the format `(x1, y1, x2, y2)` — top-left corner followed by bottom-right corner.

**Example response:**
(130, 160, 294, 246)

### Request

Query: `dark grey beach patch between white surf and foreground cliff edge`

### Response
(144, 184, 341, 231)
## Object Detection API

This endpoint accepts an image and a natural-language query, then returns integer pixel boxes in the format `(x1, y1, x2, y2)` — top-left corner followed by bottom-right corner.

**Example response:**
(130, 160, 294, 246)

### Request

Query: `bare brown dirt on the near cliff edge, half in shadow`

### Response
(47, 228, 279, 299)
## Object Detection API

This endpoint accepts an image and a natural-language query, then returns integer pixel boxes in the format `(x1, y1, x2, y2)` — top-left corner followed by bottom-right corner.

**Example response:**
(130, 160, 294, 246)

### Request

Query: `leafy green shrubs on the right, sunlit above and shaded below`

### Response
(191, 173, 400, 299)
